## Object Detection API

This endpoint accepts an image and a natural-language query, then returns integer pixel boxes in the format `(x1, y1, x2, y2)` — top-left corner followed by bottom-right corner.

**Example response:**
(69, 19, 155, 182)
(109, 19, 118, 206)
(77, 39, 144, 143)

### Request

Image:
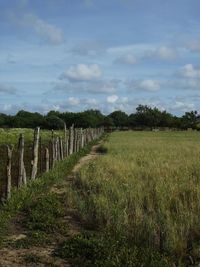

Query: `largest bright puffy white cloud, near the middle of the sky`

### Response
(60, 64, 102, 82)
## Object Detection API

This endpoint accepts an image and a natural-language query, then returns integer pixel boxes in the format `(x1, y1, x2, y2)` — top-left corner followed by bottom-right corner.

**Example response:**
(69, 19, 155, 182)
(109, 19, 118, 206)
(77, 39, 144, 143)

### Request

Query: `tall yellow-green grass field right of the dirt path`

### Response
(62, 132, 200, 267)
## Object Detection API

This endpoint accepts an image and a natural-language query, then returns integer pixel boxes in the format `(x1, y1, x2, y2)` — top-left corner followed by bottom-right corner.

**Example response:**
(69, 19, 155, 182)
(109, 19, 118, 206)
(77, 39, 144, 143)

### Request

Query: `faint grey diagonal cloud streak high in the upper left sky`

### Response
(11, 13, 64, 44)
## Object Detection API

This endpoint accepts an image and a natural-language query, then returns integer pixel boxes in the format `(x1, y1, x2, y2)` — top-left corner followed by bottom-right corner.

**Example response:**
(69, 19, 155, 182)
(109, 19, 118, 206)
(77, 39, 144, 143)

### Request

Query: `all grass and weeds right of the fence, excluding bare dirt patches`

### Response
(0, 131, 200, 267)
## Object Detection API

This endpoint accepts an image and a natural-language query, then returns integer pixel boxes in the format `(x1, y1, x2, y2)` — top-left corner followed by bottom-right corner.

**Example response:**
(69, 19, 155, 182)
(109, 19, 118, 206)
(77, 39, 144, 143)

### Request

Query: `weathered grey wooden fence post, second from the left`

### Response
(17, 134, 26, 188)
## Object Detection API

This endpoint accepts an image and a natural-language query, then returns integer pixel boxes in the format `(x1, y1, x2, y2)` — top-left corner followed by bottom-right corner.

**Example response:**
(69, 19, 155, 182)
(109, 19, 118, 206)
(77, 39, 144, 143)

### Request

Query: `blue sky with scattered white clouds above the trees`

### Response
(0, 0, 200, 115)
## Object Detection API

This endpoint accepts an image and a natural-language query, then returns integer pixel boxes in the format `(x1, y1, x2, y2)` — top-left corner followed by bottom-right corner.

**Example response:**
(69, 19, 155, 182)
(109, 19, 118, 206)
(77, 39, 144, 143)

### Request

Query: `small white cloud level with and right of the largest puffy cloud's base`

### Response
(126, 79, 161, 92)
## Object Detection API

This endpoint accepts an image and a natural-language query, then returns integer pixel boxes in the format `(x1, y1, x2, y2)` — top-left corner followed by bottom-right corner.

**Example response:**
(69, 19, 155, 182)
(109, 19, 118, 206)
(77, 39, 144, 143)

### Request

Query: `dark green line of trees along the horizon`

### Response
(0, 105, 200, 129)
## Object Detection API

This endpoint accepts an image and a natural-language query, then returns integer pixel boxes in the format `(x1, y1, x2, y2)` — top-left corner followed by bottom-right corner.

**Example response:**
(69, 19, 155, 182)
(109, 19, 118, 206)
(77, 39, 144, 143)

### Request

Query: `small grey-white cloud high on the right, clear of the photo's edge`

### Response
(144, 45, 178, 60)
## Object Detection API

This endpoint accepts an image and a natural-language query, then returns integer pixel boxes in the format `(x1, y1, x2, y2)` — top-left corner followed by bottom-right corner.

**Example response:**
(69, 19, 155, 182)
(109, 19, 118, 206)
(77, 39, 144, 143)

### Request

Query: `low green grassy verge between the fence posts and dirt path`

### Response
(0, 138, 101, 247)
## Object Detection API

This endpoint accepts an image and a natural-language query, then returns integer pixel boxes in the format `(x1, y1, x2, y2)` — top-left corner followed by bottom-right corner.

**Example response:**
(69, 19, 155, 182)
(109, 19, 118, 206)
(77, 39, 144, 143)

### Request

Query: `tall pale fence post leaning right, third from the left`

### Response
(31, 127, 40, 179)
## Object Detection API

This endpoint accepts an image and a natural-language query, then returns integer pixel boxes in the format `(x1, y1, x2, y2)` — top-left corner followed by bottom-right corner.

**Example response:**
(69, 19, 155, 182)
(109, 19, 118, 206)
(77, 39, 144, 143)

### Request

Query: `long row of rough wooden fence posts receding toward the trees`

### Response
(0, 125, 104, 201)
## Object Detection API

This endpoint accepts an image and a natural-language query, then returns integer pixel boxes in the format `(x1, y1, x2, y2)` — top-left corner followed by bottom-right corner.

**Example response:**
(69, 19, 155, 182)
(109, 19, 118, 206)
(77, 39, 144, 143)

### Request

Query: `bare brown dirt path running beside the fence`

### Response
(0, 144, 103, 267)
